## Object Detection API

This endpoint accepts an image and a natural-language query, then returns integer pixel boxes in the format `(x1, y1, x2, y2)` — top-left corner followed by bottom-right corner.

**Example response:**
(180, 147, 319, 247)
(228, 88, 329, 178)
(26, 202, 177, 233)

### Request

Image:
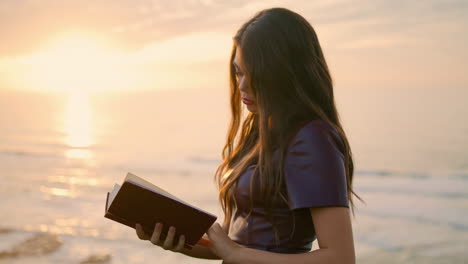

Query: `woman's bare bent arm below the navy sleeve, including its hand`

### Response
(208, 207, 356, 264)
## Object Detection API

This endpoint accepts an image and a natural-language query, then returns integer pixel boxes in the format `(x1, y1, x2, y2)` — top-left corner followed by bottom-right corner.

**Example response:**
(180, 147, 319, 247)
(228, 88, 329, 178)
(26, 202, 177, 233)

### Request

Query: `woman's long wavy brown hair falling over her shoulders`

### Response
(215, 8, 361, 245)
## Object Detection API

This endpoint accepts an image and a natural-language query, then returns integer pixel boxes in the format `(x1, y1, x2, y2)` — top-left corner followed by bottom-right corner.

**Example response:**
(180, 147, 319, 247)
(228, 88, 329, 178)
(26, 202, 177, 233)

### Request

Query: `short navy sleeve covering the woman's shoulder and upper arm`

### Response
(284, 120, 349, 210)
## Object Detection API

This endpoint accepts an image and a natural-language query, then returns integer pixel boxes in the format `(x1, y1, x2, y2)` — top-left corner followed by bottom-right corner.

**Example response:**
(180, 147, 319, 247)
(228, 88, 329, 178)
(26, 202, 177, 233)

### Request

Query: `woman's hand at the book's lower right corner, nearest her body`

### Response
(206, 223, 242, 263)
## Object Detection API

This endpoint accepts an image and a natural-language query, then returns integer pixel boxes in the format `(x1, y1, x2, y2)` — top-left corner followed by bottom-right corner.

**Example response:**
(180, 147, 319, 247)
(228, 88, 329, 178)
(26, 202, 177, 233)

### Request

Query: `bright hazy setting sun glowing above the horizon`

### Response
(26, 33, 132, 93)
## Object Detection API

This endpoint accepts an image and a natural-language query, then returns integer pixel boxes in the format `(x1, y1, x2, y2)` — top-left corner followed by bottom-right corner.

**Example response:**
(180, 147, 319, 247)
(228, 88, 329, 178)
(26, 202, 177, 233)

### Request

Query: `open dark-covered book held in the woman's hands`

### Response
(104, 173, 217, 249)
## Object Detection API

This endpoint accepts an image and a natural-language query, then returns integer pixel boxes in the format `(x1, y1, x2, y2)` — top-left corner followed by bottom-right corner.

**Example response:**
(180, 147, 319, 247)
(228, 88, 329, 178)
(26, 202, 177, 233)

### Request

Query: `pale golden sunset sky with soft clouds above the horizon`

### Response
(0, 0, 468, 92)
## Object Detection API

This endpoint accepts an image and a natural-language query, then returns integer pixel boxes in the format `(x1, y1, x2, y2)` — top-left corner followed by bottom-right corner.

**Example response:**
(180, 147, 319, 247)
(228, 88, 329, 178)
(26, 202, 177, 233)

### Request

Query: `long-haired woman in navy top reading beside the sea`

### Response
(137, 8, 360, 263)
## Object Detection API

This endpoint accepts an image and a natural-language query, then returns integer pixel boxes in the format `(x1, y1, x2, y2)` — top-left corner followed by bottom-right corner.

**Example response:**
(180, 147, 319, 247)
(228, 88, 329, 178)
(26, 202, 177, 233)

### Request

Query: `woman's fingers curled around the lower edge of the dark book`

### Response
(135, 223, 185, 253)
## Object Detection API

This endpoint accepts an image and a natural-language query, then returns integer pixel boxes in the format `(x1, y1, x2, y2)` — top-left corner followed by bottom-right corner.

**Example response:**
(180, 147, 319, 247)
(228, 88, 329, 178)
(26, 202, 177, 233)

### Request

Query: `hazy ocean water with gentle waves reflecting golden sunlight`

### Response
(0, 88, 468, 264)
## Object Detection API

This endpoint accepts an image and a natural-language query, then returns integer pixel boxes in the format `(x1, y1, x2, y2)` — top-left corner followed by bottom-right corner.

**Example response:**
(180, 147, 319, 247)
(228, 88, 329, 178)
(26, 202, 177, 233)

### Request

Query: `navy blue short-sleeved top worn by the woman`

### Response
(228, 120, 349, 253)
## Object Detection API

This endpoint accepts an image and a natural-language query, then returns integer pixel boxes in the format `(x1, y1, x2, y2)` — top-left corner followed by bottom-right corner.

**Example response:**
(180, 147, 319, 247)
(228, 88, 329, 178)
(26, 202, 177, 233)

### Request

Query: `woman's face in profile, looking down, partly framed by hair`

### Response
(233, 47, 257, 113)
